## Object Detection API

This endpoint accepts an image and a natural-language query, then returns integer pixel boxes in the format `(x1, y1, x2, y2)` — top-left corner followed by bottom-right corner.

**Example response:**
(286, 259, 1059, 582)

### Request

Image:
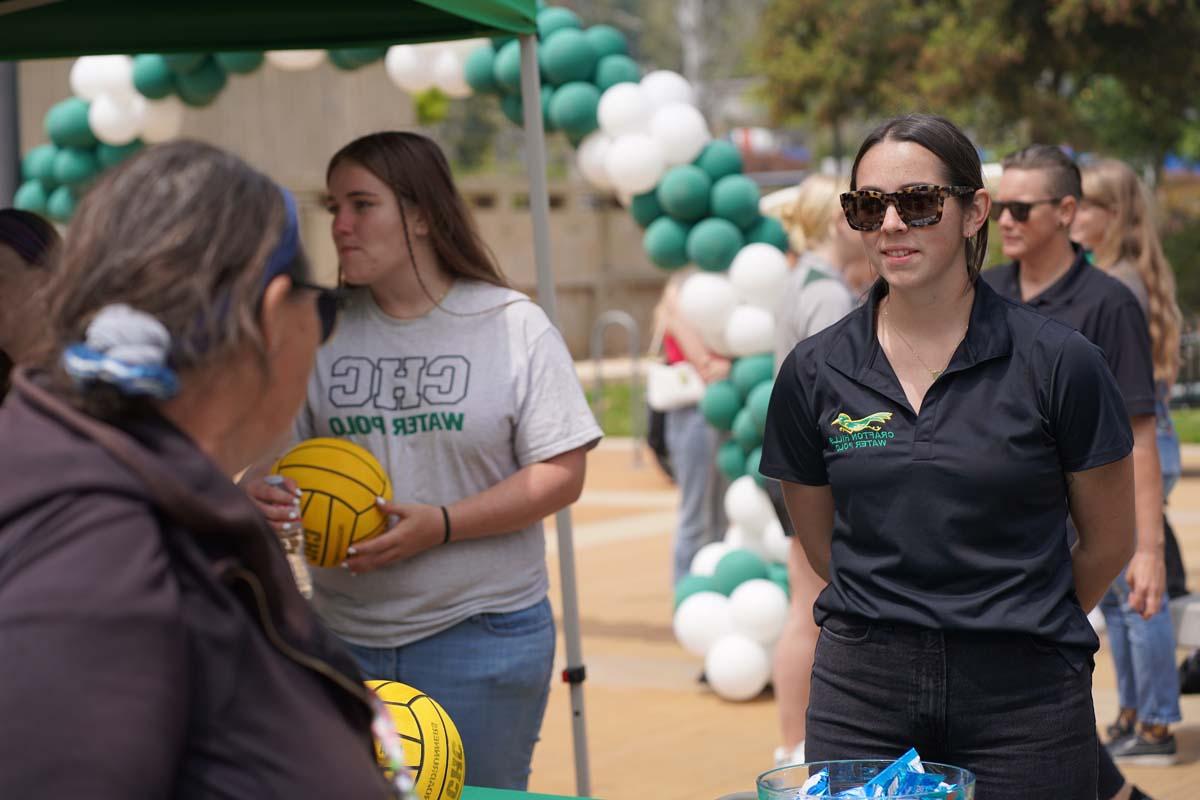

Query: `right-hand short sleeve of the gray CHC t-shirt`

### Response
(514, 326, 604, 467)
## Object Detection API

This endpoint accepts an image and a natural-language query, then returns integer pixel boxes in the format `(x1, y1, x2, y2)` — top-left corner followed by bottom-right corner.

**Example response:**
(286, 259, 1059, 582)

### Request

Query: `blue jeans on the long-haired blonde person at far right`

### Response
(1100, 572, 1182, 724)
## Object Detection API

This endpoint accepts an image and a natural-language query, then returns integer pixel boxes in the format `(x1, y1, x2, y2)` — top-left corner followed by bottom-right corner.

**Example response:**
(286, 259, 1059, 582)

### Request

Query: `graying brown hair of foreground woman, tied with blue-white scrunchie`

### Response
(40, 140, 286, 417)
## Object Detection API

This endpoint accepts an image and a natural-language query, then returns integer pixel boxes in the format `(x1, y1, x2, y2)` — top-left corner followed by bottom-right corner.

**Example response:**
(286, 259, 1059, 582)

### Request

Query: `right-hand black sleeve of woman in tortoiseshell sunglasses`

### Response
(1049, 332, 1133, 473)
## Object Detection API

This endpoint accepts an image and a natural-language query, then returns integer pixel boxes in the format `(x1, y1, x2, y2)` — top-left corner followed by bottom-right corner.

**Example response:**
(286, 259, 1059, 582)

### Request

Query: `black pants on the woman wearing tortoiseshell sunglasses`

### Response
(804, 618, 1098, 800)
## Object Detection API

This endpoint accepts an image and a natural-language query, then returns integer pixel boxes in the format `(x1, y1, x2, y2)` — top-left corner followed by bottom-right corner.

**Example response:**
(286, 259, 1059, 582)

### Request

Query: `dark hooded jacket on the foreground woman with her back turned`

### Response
(0, 373, 390, 800)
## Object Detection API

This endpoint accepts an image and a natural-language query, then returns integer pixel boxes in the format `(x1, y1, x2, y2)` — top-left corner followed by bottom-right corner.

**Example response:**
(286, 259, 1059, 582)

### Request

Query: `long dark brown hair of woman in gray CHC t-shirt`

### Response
(325, 131, 509, 302)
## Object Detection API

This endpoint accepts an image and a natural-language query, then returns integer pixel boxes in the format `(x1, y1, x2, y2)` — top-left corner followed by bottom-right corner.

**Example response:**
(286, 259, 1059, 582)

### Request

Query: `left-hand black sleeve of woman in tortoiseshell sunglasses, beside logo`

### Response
(758, 348, 829, 486)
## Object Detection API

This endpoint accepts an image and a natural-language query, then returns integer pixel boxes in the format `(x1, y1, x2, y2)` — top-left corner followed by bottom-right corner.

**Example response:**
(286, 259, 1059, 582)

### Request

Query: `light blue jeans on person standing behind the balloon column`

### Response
(666, 405, 726, 582)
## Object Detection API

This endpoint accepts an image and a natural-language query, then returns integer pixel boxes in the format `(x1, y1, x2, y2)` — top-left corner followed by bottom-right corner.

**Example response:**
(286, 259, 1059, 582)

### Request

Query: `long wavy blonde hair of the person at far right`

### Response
(1082, 158, 1182, 384)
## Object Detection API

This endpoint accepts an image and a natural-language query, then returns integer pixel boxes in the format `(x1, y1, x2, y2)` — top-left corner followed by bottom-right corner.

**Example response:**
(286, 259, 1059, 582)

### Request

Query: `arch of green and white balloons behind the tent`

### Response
(13, 7, 788, 699)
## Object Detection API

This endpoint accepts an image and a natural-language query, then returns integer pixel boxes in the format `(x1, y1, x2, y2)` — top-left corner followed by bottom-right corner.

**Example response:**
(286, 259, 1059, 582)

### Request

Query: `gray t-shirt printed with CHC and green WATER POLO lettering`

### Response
(295, 278, 604, 648)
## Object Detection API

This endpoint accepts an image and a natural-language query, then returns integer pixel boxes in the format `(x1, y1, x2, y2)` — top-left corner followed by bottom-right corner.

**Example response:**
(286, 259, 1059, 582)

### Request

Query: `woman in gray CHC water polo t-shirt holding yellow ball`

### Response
(253, 132, 602, 789)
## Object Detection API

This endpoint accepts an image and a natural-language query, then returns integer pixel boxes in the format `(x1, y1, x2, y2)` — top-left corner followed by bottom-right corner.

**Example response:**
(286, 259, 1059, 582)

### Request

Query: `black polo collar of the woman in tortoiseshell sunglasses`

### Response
(826, 279, 1013, 388)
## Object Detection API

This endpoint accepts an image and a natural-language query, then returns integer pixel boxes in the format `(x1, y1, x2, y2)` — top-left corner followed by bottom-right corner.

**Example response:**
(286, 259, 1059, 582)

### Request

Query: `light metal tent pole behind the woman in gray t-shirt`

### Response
(521, 35, 592, 798)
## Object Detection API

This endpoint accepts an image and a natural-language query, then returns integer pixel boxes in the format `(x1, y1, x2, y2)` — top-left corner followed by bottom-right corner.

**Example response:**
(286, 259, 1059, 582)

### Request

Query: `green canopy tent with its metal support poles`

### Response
(0, 0, 590, 796)
